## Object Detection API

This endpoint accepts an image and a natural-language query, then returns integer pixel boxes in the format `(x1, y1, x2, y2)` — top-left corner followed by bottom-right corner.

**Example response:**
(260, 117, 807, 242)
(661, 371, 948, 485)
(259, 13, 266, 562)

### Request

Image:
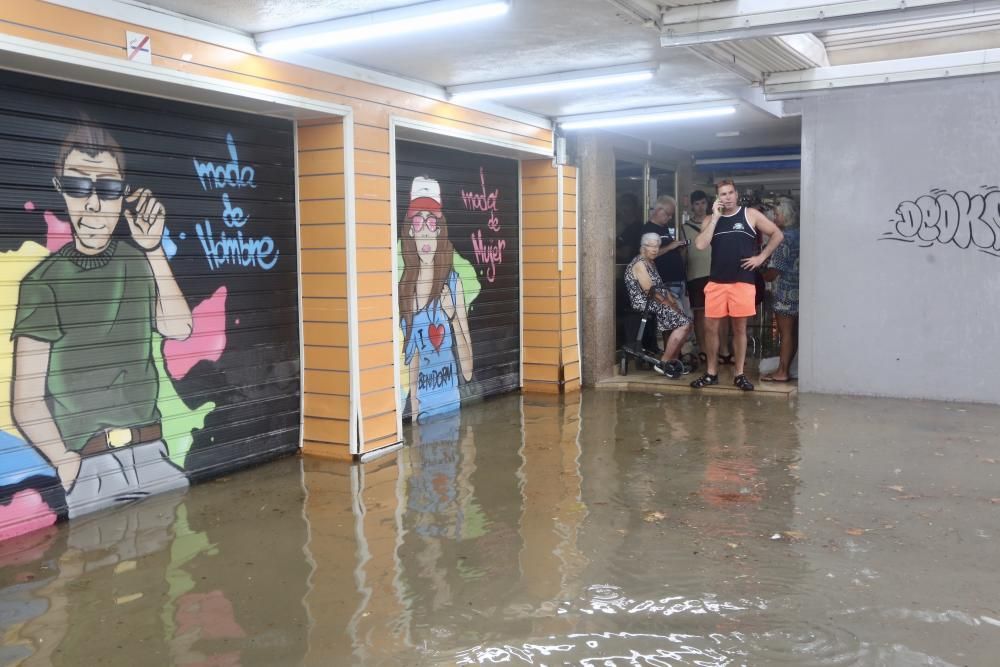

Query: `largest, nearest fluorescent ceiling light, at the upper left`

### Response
(254, 0, 510, 55)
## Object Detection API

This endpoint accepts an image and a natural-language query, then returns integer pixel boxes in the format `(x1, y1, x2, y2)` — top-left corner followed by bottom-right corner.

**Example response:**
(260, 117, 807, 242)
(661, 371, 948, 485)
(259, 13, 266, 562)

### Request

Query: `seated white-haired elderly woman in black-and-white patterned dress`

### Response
(625, 234, 691, 375)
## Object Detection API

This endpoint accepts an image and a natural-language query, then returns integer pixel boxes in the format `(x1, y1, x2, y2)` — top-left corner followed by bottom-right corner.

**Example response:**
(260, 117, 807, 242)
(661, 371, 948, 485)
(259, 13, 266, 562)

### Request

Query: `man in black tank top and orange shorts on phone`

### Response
(691, 179, 784, 391)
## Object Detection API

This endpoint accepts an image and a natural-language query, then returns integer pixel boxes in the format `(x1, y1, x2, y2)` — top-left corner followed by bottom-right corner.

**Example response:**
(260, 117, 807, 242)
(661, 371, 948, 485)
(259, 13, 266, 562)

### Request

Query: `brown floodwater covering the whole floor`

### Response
(0, 390, 1000, 667)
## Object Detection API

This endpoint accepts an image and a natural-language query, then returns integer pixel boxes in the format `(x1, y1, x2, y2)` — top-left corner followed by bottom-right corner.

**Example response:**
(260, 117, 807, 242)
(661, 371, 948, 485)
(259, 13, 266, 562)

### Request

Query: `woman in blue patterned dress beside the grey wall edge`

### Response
(760, 197, 799, 382)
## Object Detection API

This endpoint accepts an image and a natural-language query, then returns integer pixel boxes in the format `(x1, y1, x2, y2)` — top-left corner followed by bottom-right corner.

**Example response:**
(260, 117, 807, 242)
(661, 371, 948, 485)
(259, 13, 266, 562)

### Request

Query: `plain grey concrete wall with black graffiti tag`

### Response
(799, 76, 1000, 403)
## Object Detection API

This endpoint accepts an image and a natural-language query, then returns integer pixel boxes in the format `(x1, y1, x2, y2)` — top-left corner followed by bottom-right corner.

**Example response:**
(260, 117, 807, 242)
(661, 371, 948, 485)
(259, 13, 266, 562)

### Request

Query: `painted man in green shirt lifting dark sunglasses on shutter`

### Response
(11, 119, 192, 518)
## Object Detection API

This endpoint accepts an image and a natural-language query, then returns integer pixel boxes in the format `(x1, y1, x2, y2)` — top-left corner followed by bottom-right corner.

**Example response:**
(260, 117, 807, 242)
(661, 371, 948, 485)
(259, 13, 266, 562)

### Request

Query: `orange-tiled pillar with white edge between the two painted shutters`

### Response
(298, 112, 401, 459)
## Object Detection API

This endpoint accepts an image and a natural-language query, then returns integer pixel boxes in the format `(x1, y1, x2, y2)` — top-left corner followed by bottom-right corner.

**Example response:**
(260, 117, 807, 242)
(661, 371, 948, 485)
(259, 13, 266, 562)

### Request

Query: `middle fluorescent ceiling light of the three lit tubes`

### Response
(448, 64, 656, 101)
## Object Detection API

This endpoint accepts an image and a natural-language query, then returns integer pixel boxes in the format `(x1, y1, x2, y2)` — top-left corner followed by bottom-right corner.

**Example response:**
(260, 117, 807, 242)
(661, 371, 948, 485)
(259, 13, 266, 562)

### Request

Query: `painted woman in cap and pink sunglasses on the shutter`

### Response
(399, 176, 473, 422)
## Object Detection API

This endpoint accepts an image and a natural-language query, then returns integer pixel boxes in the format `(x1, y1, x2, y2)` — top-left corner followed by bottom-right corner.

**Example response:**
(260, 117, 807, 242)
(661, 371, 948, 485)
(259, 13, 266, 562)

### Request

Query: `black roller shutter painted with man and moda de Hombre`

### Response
(0, 72, 300, 537)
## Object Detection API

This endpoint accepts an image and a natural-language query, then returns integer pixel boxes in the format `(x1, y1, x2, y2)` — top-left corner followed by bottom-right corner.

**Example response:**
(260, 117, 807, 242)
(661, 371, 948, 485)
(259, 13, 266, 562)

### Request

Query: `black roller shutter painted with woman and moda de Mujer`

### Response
(396, 141, 520, 421)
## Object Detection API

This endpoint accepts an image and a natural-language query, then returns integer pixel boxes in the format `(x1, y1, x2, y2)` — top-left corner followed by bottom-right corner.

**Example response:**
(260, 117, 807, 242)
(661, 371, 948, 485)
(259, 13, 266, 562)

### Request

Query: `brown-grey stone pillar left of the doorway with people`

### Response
(578, 134, 615, 385)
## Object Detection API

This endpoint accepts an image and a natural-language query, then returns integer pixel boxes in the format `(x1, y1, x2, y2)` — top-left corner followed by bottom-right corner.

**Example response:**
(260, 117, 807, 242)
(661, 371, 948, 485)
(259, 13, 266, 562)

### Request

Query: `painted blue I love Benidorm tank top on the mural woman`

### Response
(400, 271, 460, 422)
